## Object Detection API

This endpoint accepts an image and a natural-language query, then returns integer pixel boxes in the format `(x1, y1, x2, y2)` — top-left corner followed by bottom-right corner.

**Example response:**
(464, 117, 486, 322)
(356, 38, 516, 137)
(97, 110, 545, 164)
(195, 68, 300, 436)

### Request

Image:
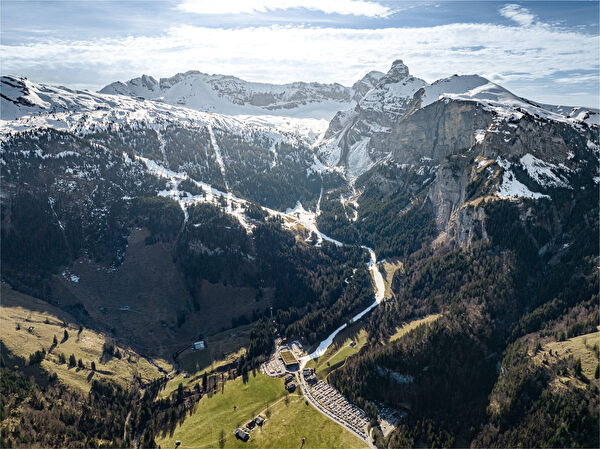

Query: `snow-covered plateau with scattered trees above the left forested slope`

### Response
(0, 76, 327, 146)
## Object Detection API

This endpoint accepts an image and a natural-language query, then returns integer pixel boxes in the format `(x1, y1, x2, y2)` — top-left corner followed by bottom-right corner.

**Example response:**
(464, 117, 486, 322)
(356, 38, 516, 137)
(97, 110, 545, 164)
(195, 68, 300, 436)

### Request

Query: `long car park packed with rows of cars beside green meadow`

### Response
(303, 373, 369, 438)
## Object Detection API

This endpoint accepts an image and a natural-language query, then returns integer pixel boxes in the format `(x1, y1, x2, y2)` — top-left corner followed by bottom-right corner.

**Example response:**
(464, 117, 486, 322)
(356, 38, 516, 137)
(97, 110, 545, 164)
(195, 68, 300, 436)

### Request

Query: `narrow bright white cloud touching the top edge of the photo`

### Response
(177, 0, 392, 17)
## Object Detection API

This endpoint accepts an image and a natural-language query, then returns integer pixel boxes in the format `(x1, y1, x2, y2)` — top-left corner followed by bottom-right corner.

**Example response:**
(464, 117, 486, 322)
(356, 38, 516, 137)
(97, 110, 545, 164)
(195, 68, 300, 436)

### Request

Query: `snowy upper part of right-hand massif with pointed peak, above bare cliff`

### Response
(319, 60, 600, 177)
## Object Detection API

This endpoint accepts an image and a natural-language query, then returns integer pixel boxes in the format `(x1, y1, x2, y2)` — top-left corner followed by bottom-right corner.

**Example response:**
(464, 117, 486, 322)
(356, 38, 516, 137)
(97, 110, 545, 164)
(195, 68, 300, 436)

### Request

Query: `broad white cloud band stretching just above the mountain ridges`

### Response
(0, 24, 599, 104)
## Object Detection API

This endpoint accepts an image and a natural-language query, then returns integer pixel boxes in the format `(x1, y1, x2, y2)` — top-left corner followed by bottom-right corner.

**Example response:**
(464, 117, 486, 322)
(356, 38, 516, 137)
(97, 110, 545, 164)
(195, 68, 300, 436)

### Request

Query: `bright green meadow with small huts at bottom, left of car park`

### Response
(156, 374, 364, 449)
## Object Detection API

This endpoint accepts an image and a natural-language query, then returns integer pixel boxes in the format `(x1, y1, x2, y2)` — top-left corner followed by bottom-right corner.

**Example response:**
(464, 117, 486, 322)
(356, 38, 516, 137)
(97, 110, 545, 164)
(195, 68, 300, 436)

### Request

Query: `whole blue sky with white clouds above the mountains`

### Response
(0, 0, 600, 107)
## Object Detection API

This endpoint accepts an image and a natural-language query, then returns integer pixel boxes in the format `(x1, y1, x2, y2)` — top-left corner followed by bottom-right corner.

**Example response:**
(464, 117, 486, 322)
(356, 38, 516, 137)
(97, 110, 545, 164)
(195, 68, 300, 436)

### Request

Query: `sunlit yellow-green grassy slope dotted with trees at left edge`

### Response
(0, 283, 169, 392)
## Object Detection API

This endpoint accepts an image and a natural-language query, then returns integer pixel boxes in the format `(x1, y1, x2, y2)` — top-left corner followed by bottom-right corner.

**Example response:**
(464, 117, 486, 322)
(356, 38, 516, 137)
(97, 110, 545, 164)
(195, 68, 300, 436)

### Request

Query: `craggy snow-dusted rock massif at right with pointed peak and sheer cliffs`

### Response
(312, 61, 600, 252)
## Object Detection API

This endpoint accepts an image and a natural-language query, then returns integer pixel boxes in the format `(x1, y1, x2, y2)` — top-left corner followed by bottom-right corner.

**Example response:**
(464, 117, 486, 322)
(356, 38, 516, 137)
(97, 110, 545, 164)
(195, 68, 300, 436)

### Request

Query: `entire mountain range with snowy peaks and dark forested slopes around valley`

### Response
(0, 60, 600, 448)
